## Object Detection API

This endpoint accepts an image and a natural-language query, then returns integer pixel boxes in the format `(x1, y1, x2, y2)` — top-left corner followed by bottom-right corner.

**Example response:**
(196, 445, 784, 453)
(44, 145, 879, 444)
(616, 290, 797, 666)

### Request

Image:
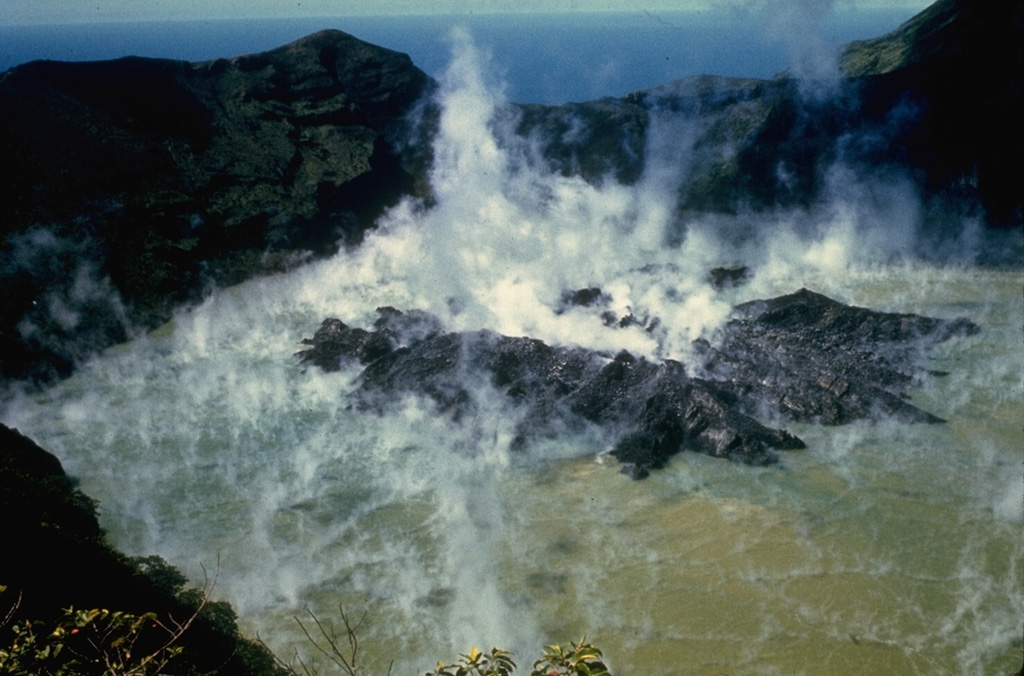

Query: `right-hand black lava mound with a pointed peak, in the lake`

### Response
(698, 289, 978, 425)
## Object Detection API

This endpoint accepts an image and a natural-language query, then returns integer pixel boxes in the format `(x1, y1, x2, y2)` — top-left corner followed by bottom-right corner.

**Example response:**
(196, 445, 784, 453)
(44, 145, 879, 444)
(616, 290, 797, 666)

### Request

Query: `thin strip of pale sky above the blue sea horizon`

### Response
(0, 0, 933, 26)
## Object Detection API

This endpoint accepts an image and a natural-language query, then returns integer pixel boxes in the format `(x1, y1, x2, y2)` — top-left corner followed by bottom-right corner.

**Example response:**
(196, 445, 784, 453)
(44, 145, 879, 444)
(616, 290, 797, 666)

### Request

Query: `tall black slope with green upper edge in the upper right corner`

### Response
(840, 0, 1024, 227)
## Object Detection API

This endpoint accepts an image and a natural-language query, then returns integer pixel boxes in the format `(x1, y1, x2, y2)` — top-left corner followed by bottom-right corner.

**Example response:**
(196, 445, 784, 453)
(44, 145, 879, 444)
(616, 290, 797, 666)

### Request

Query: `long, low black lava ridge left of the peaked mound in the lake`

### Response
(300, 308, 803, 477)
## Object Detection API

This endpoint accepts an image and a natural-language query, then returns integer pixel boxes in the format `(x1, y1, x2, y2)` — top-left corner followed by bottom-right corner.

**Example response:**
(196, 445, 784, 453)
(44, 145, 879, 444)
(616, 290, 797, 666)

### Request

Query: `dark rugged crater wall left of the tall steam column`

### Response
(0, 31, 431, 379)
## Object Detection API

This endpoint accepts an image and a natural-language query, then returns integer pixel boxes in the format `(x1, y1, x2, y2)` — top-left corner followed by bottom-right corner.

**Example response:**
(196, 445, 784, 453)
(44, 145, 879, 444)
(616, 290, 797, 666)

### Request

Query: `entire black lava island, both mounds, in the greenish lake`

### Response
(299, 289, 978, 478)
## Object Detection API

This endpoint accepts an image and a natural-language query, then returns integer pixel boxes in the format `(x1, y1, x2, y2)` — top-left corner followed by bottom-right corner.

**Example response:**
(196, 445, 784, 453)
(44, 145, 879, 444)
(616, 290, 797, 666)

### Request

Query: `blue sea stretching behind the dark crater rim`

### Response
(0, 9, 913, 103)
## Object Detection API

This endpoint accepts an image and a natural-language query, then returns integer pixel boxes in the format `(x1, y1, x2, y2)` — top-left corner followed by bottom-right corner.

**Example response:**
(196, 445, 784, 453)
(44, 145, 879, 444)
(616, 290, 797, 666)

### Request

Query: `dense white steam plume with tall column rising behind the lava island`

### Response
(353, 27, 741, 354)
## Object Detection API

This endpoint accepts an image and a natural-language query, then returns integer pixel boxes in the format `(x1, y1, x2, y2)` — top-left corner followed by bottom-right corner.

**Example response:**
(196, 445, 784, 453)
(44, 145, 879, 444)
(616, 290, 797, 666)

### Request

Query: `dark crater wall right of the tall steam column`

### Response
(521, 0, 1024, 228)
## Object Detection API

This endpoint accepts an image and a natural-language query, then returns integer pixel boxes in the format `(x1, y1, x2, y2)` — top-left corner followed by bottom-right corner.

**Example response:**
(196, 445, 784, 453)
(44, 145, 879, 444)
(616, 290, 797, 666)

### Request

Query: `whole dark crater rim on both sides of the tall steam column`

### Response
(0, 0, 1024, 383)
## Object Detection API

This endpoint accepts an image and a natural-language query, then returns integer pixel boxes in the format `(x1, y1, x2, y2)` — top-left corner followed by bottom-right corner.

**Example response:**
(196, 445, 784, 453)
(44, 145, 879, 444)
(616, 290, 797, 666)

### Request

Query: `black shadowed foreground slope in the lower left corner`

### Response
(0, 424, 283, 676)
